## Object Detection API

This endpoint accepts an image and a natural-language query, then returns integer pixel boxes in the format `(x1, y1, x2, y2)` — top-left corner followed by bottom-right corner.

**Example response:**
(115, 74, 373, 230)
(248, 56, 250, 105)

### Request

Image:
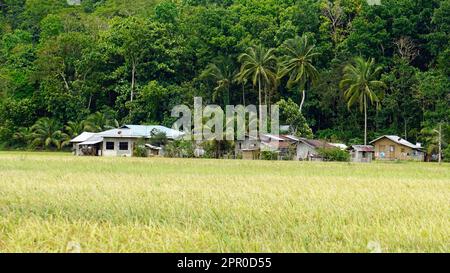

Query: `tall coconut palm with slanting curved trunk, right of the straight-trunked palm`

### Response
(279, 35, 319, 113)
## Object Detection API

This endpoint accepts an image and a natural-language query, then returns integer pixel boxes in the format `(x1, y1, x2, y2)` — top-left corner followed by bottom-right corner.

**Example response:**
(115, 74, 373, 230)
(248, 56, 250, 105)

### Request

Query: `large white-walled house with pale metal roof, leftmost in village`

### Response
(70, 125, 184, 156)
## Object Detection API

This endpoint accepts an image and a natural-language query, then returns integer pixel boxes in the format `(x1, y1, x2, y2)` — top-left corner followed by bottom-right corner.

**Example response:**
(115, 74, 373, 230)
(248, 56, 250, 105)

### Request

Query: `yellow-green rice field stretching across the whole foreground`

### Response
(0, 152, 450, 252)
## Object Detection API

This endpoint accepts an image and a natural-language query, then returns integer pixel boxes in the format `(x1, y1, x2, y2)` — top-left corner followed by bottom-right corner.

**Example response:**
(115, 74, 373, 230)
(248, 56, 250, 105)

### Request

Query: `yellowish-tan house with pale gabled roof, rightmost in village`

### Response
(370, 135, 425, 161)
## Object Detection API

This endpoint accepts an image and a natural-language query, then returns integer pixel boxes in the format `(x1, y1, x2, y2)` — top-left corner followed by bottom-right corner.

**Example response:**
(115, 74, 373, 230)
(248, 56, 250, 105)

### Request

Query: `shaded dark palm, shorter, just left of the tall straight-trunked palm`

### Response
(200, 57, 236, 105)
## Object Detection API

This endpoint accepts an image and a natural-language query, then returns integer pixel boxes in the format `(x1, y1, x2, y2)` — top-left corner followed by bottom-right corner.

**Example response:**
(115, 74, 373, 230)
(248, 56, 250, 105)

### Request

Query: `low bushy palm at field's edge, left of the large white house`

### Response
(31, 118, 70, 150)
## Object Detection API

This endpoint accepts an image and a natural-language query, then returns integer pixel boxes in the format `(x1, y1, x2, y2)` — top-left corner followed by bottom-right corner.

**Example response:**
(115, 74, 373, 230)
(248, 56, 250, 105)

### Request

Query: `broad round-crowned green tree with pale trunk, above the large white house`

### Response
(106, 17, 183, 101)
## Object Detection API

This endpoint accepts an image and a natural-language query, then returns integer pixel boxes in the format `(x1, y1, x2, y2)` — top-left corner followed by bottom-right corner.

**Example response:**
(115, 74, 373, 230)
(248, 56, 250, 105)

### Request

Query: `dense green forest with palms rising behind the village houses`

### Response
(0, 0, 450, 158)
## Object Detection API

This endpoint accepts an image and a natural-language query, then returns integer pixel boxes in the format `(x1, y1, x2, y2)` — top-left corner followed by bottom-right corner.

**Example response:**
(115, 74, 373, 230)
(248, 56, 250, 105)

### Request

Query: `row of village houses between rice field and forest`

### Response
(71, 125, 425, 163)
